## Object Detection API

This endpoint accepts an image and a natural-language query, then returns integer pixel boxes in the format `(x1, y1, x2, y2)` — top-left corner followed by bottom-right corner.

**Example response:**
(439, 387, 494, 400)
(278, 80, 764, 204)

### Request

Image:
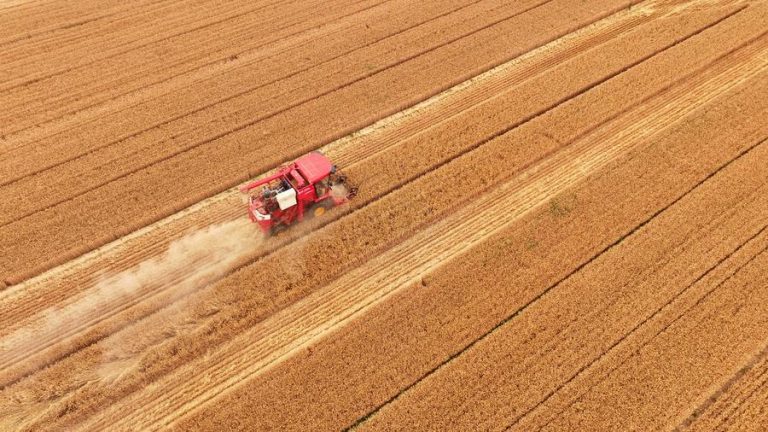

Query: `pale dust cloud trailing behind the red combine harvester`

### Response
(0, 219, 263, 376)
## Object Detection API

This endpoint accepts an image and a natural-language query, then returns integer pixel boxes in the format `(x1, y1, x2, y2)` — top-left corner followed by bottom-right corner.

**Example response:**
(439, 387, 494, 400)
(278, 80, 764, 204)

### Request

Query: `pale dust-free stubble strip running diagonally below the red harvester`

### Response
(81, 32, 766, 427)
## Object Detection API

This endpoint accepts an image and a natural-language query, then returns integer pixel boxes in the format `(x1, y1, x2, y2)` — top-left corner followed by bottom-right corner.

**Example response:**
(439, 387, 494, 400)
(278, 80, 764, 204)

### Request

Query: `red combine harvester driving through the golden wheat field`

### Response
(240, 151, 357, 235)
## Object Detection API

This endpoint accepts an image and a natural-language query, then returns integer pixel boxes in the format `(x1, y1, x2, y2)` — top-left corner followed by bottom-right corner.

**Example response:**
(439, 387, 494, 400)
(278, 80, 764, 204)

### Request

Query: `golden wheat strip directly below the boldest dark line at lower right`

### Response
(363, 146, 768, 431)
